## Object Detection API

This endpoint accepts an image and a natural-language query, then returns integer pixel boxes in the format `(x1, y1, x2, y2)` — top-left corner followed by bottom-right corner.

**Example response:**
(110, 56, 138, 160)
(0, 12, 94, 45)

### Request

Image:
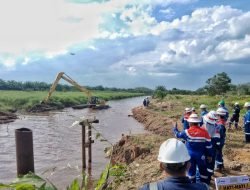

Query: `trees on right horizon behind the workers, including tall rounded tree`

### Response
(154, 72, 250, 98)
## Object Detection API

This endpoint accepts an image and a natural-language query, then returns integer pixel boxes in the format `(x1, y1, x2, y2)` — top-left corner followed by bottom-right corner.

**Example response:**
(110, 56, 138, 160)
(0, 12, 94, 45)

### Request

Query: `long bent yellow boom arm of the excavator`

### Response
(43, 72, 92, 104)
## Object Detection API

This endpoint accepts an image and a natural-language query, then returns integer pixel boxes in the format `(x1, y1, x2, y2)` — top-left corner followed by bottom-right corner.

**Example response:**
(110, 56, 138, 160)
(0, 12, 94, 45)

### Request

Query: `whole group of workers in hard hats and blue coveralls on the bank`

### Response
(142, 100, 250, 190)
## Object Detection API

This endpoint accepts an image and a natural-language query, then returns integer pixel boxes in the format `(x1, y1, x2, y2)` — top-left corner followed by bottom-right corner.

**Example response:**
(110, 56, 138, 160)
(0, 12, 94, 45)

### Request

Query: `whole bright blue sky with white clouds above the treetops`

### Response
(0, 0, 250, 90)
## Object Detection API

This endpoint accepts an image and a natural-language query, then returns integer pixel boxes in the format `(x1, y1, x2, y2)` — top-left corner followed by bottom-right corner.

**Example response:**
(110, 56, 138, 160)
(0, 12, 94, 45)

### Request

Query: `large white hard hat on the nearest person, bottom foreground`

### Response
(158, 138, 190, 164)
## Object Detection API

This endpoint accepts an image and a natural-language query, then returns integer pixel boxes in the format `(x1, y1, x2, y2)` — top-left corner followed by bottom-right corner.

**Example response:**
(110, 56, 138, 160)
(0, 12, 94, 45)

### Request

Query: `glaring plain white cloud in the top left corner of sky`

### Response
(0, 0, 133, 59)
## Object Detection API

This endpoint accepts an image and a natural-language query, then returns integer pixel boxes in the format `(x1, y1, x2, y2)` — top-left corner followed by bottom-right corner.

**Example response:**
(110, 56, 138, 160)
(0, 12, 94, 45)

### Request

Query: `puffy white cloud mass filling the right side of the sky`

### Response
(108, 6, 250, 76)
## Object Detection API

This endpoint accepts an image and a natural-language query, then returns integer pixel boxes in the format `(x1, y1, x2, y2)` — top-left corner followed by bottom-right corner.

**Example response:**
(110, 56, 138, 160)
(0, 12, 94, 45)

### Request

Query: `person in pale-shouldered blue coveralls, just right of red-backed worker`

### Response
(202, 110, 220, 181)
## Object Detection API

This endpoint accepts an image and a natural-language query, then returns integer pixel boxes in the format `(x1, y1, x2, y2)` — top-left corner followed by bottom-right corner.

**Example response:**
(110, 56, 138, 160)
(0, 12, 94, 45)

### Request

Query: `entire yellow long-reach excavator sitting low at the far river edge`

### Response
(42, 72, 109, 109)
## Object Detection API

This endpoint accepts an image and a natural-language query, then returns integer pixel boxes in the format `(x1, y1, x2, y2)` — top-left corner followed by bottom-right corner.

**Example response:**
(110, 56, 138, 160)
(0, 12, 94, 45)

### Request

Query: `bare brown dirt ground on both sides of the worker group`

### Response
(112, 102, 250, 190)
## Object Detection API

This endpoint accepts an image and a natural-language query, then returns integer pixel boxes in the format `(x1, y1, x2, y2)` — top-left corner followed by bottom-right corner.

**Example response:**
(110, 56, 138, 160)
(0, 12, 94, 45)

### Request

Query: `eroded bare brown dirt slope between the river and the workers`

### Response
(110, 107, 173, 190)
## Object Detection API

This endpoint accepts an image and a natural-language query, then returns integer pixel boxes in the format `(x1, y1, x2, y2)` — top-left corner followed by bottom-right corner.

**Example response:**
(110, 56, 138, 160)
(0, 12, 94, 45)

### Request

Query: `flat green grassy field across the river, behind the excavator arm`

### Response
(0, 90, 143, 111)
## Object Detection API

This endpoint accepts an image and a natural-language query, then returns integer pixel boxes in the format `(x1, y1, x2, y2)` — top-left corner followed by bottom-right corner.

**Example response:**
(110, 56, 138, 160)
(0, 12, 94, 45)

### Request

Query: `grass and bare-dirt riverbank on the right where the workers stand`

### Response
(110, 95, 250, 190)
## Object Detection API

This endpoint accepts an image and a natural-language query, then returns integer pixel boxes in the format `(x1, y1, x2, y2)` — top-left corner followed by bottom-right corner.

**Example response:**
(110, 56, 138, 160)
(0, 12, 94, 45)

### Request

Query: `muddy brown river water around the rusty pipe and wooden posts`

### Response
(0, 97, 144, 189)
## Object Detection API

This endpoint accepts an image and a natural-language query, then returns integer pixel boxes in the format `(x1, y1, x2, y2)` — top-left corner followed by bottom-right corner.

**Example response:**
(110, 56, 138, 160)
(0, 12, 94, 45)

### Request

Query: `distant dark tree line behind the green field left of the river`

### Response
(0, 79, 153, 94)
